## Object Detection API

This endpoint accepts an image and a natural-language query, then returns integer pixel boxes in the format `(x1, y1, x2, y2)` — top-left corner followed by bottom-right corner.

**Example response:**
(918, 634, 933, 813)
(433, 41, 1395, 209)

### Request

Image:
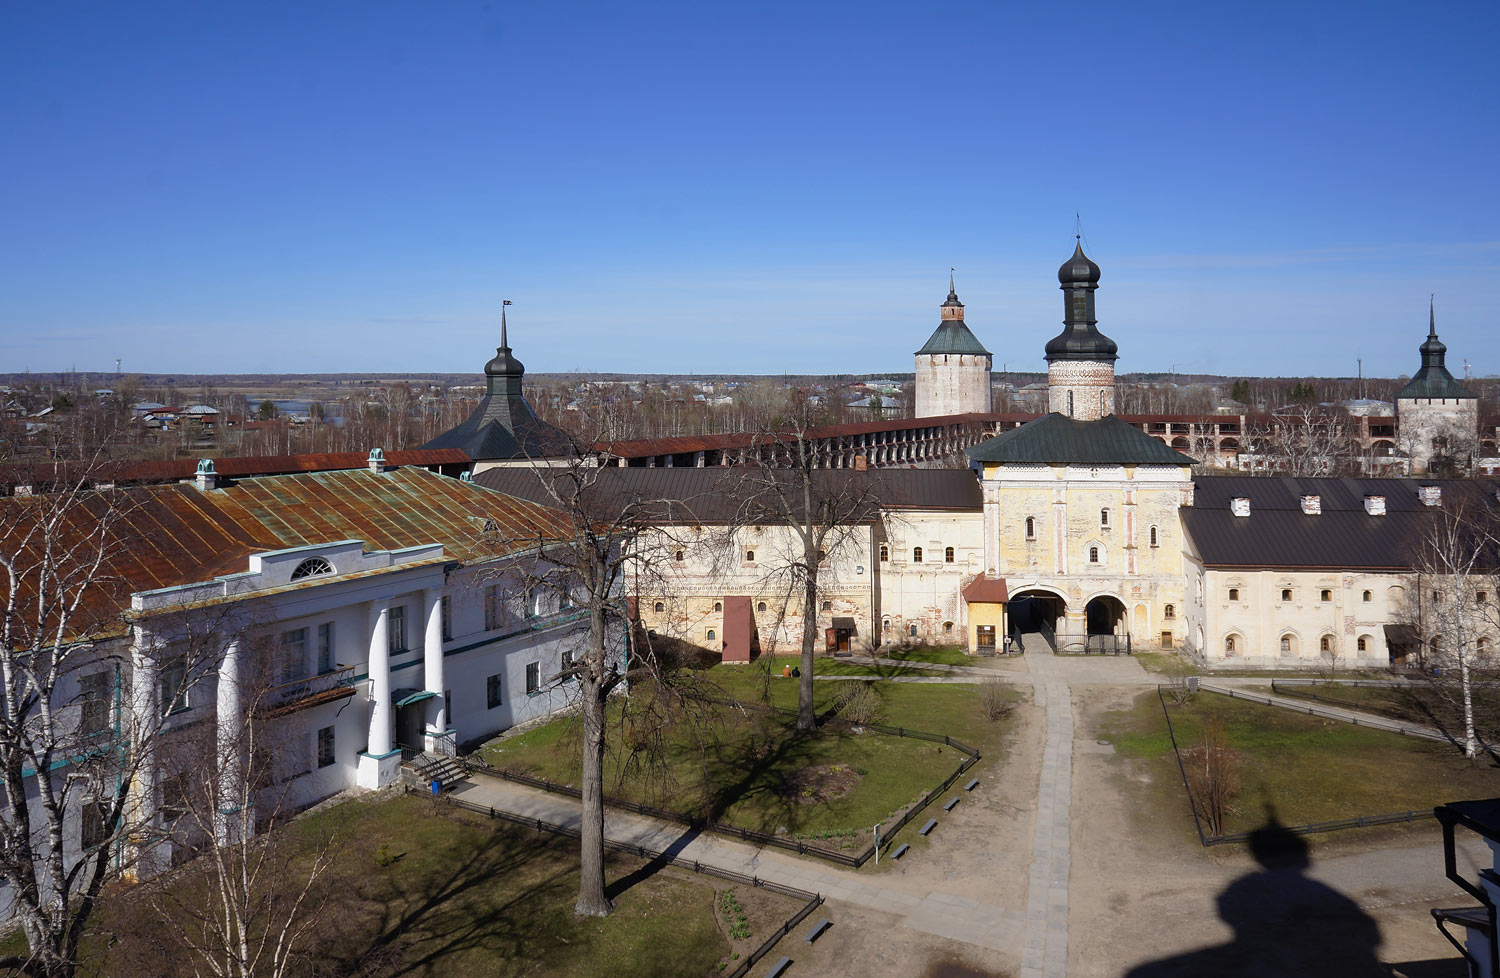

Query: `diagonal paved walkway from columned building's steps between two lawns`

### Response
(456, 774, 1023, 953)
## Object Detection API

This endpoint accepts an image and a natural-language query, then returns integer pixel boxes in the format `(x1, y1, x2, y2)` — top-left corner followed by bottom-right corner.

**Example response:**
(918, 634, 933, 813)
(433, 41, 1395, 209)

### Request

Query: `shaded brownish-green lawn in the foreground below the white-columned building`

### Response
(81, 795, 798, 978)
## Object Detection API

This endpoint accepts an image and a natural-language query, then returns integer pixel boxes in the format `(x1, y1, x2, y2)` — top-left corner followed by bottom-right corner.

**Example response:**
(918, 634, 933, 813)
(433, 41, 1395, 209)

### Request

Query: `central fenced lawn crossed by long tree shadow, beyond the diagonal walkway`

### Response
(483, 665, 1020, 849)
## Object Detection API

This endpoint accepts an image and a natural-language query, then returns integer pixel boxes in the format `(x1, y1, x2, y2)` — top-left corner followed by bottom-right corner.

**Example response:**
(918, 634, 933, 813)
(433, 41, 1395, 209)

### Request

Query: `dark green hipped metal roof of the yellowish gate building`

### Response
(969, 414, 1197, 465)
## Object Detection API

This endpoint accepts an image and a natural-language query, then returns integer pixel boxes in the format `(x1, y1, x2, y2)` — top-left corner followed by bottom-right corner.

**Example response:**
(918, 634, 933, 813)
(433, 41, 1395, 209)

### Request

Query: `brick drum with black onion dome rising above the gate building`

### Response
(1047, 237, 1119, 422)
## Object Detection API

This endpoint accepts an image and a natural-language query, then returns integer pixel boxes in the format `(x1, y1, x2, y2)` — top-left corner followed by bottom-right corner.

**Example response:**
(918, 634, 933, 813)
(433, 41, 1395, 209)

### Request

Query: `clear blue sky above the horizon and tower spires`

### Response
(0, 0, 1500, 375)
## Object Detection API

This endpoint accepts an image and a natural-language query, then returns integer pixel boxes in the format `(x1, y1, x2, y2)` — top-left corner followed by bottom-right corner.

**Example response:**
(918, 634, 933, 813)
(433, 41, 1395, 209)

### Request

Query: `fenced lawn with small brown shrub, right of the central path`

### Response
(1104, 692, 1500, 833)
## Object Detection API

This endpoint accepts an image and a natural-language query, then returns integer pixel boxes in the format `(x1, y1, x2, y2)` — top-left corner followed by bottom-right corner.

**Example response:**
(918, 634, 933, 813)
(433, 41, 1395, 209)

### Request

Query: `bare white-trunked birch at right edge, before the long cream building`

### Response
(1407, 494, 1500, 758)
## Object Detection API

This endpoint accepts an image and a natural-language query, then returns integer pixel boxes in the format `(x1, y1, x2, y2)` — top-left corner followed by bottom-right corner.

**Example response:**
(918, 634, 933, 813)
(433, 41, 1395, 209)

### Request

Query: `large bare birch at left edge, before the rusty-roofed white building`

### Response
(0, 464, 222, 978)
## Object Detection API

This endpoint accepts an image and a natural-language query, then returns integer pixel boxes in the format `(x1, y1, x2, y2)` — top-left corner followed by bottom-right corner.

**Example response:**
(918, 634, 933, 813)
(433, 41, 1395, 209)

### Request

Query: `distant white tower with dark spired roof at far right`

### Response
(1397, 300, 1479, 474)
